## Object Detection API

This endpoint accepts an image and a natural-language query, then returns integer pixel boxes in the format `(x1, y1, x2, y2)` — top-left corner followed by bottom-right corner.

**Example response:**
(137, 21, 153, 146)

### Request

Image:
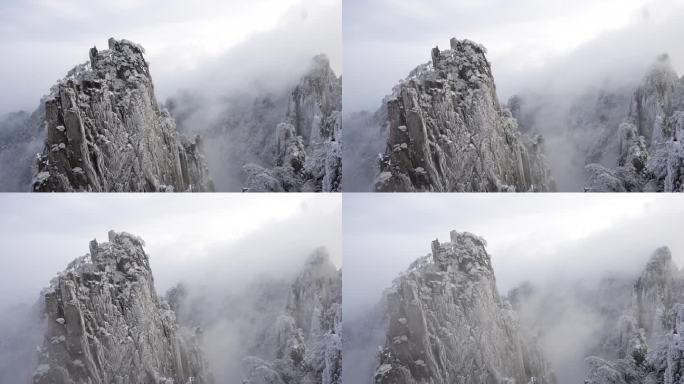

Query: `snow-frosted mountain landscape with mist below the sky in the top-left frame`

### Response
(0, 39, 342, 192)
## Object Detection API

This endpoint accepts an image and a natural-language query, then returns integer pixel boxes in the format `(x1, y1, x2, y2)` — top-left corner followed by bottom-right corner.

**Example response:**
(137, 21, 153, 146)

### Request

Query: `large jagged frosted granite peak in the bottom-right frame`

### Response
(374, 231, 555, 384)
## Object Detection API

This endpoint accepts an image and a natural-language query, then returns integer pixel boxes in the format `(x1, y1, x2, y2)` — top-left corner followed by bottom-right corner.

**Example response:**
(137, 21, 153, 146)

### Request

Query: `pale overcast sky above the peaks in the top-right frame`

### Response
(343, 0, 684, 112)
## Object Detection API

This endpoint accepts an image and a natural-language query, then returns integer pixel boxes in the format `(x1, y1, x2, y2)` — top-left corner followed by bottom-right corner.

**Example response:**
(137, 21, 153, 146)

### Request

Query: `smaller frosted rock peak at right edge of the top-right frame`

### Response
(586, 55, 684, 192)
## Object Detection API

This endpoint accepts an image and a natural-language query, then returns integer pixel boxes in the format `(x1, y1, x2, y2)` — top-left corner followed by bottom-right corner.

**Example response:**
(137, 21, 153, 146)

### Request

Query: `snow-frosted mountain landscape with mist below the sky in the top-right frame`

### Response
(344, 36, 684, 192)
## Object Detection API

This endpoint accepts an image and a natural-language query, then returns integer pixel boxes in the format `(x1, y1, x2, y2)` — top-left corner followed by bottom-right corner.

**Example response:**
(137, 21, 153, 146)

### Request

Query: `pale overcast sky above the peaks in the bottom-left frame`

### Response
(0, 194, 341, 308)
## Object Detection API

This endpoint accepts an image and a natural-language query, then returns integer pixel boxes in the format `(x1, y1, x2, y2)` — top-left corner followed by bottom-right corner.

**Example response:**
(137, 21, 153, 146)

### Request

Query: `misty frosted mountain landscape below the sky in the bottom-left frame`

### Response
(0, 231, 342, 384)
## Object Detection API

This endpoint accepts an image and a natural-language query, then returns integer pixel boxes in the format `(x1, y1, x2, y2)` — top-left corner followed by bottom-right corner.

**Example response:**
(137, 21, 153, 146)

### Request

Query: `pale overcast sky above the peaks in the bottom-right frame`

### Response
(343, 193, 684, 317)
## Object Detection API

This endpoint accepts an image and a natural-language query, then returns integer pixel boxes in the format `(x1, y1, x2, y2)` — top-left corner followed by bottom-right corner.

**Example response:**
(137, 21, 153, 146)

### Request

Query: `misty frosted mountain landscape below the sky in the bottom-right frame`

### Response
(343, 231, 684, 384)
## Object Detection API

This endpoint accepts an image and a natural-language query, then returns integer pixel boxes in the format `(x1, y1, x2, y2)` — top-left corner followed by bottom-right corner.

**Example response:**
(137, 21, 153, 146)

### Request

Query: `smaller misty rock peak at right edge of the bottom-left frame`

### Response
(243, 249, 342, 384)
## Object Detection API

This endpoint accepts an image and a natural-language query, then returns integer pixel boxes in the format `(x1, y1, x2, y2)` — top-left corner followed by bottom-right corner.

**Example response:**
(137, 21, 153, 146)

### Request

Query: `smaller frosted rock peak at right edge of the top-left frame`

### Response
(244, 55, 342, 192)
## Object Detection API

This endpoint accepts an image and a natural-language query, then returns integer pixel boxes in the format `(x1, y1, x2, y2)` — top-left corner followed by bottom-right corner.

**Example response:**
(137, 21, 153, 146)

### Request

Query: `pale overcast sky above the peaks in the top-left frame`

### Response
(0, 0, 342, 115)
